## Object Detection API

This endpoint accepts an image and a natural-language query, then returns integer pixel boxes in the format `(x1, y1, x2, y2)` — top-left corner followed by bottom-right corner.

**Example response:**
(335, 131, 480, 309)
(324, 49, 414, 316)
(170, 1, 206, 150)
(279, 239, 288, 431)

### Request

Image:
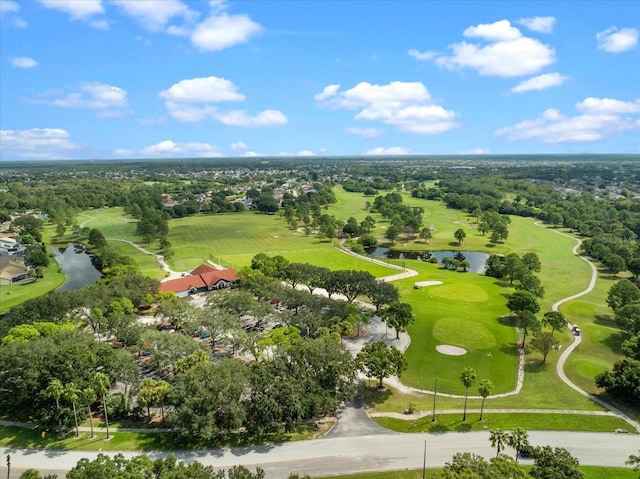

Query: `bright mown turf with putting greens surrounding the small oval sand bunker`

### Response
(395, 261, 518, 394)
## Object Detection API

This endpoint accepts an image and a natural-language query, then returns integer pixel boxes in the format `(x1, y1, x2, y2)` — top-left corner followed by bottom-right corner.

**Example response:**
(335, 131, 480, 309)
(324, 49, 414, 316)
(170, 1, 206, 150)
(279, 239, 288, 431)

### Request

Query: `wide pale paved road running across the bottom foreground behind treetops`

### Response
(0, 431, 640, 479)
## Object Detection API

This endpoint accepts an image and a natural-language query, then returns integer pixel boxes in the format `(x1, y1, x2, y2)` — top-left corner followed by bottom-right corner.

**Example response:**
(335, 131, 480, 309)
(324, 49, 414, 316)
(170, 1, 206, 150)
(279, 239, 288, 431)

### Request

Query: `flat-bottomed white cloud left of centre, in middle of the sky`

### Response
(160, 76, 245, 103)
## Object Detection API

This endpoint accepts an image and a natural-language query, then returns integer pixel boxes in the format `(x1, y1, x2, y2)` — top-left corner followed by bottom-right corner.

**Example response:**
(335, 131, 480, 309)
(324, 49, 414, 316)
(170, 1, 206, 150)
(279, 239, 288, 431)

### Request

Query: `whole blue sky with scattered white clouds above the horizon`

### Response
(0, 0, 640, 160)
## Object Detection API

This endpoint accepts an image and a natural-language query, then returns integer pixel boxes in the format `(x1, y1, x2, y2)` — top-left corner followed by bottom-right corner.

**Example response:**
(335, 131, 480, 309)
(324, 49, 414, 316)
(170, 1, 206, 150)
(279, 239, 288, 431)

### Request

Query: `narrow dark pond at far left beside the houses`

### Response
(51, 243, 102, 293)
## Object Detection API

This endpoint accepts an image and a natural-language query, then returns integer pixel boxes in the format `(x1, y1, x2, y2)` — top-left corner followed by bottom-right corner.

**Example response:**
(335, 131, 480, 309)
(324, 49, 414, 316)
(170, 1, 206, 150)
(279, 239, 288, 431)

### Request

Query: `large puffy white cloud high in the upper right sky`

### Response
(420, 20, 556, 77)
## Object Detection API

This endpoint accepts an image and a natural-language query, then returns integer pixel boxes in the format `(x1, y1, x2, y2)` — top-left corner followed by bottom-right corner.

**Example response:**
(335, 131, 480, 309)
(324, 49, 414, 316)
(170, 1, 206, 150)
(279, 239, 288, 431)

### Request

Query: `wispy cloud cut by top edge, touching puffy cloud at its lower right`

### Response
(112, 0, 197, 32)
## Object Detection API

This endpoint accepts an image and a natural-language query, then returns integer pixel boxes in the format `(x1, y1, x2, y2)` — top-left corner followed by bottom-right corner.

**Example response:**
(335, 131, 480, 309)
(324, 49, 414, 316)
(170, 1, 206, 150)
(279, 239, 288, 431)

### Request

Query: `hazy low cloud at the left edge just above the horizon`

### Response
(0, 128, 80, 160)
